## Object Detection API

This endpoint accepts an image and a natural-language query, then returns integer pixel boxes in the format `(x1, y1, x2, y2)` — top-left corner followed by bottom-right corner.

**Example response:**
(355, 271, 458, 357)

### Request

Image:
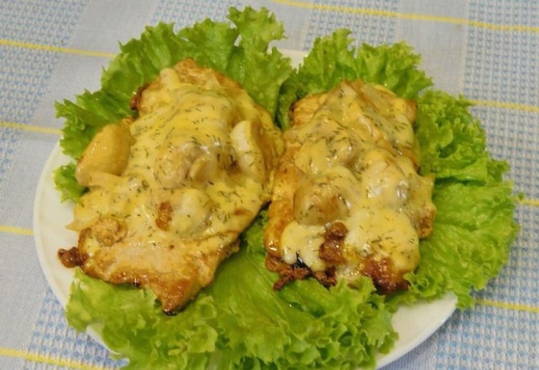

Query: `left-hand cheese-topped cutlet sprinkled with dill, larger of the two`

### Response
(64, 60, 283, 312)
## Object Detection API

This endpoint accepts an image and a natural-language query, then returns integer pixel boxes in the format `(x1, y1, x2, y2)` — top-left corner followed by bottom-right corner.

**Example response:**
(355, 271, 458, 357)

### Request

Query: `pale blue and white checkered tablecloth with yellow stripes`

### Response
(0, 0, 539, 369)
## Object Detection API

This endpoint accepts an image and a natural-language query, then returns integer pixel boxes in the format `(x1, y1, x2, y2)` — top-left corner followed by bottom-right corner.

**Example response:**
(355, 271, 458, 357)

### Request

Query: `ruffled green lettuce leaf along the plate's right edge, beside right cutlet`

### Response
(392, 91, 518, 308)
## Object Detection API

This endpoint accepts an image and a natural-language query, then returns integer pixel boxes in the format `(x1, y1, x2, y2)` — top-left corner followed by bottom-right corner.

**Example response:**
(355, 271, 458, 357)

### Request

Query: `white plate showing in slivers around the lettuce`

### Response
(34, 50, 456, 367)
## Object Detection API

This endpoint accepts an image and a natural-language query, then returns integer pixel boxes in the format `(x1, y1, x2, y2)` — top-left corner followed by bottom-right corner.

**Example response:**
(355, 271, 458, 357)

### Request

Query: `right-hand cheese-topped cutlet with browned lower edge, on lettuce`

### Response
(264, 81, 436, 292)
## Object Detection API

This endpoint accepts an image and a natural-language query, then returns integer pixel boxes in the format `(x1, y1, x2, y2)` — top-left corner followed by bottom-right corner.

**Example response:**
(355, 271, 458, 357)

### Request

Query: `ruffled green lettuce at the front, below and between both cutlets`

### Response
(67, 212, 396, 369)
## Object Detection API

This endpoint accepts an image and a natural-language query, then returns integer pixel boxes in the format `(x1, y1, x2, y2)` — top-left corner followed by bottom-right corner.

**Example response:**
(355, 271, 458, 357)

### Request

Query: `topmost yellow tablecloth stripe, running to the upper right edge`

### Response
(272, 0, 539, 33)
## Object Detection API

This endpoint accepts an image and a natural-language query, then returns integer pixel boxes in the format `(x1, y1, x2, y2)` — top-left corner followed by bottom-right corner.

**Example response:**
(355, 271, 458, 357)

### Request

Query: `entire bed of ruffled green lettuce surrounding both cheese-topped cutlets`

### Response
(49, 8, 517, 369)
